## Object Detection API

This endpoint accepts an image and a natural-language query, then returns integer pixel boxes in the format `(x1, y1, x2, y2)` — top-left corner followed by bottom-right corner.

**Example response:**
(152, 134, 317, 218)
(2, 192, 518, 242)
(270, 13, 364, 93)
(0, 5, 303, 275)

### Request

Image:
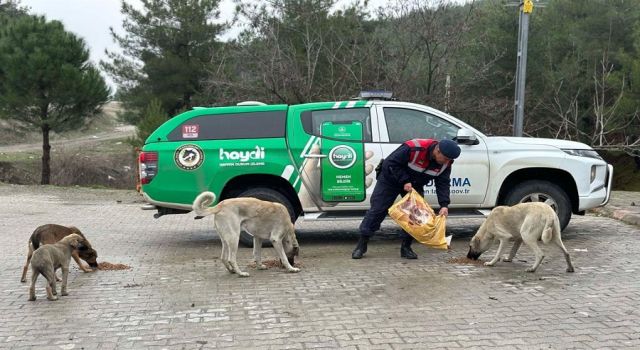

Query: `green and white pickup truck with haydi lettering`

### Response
(139, 94, 613, 244)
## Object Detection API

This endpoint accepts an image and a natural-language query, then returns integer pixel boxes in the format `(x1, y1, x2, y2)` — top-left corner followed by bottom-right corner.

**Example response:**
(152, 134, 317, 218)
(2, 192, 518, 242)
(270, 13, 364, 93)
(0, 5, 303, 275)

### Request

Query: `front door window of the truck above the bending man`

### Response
(384, 107, 459, 143)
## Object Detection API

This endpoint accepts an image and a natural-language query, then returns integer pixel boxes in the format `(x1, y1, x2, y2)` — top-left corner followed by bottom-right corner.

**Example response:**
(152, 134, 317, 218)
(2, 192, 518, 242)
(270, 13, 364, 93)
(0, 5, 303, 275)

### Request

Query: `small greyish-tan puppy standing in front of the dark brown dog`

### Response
(29, 233, 85, 301)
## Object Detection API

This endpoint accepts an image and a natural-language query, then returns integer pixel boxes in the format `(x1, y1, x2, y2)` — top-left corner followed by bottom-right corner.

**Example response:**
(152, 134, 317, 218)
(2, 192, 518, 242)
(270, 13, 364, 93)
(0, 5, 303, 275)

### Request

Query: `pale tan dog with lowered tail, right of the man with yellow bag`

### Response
(467, 202, 573, 272)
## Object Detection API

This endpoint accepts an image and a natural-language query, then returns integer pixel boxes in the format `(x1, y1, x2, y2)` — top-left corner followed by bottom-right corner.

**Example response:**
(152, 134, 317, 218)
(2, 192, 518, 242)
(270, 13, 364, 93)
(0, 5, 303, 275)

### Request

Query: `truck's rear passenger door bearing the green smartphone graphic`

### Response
(287, 101, 382, 212)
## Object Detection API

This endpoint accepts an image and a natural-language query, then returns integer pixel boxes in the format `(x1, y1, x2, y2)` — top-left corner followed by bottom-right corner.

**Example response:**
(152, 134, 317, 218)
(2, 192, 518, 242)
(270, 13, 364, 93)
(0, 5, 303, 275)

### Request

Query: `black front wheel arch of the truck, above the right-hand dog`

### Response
(496, 168, 579, 214)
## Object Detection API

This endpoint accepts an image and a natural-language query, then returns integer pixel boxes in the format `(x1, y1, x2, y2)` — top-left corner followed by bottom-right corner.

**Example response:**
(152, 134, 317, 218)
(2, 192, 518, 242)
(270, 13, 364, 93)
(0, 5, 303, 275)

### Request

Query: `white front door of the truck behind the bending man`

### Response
(377, 104, 489, 208)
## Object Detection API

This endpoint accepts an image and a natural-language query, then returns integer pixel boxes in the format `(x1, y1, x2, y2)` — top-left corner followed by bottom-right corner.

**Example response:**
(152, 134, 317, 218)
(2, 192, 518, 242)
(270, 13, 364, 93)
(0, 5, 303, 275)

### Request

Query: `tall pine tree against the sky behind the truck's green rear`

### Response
(101, 0, 225, 120)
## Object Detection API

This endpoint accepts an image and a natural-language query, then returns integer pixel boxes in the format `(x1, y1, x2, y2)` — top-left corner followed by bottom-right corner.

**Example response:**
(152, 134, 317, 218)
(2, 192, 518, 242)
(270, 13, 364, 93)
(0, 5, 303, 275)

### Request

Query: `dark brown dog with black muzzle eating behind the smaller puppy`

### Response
(20, 224, 98, 283)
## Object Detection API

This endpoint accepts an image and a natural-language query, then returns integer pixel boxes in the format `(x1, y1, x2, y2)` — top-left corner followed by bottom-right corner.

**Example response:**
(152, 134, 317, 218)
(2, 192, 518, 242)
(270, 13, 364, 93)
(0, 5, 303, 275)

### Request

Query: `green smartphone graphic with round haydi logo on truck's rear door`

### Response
(321, 120, 366, 202)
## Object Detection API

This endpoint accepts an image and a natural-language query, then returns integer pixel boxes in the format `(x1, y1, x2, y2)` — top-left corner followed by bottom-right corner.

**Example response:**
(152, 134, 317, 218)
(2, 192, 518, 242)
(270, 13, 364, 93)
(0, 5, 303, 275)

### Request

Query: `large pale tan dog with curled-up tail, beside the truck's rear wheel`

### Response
(193, 192, 300, 277)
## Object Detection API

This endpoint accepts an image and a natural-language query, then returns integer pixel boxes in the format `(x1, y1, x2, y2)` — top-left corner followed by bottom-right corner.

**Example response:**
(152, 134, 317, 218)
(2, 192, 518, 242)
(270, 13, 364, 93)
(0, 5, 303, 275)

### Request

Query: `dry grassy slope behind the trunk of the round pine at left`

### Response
(0, 102, 137, 189)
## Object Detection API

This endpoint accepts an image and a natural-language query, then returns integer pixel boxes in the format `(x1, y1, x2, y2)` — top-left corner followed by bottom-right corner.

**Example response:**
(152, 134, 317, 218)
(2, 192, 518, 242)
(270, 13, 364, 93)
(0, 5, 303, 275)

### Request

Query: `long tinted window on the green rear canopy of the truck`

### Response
(167, 111, 287, 141)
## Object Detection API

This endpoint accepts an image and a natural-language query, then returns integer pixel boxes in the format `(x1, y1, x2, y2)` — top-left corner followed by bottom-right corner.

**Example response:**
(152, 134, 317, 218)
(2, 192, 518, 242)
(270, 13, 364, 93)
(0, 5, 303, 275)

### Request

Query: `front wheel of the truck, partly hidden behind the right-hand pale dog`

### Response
(504, 180, 571, 230)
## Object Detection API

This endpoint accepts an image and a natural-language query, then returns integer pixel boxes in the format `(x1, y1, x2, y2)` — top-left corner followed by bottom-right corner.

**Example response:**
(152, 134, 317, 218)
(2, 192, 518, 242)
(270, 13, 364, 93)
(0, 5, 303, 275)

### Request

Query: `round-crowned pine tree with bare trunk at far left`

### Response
(0, 15, 110, 185)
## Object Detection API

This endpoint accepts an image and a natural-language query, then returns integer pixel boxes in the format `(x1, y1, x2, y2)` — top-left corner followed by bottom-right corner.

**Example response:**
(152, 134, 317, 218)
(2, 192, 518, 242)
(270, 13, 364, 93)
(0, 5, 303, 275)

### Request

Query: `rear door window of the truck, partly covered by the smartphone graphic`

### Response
(300, 108, 371, 142)
